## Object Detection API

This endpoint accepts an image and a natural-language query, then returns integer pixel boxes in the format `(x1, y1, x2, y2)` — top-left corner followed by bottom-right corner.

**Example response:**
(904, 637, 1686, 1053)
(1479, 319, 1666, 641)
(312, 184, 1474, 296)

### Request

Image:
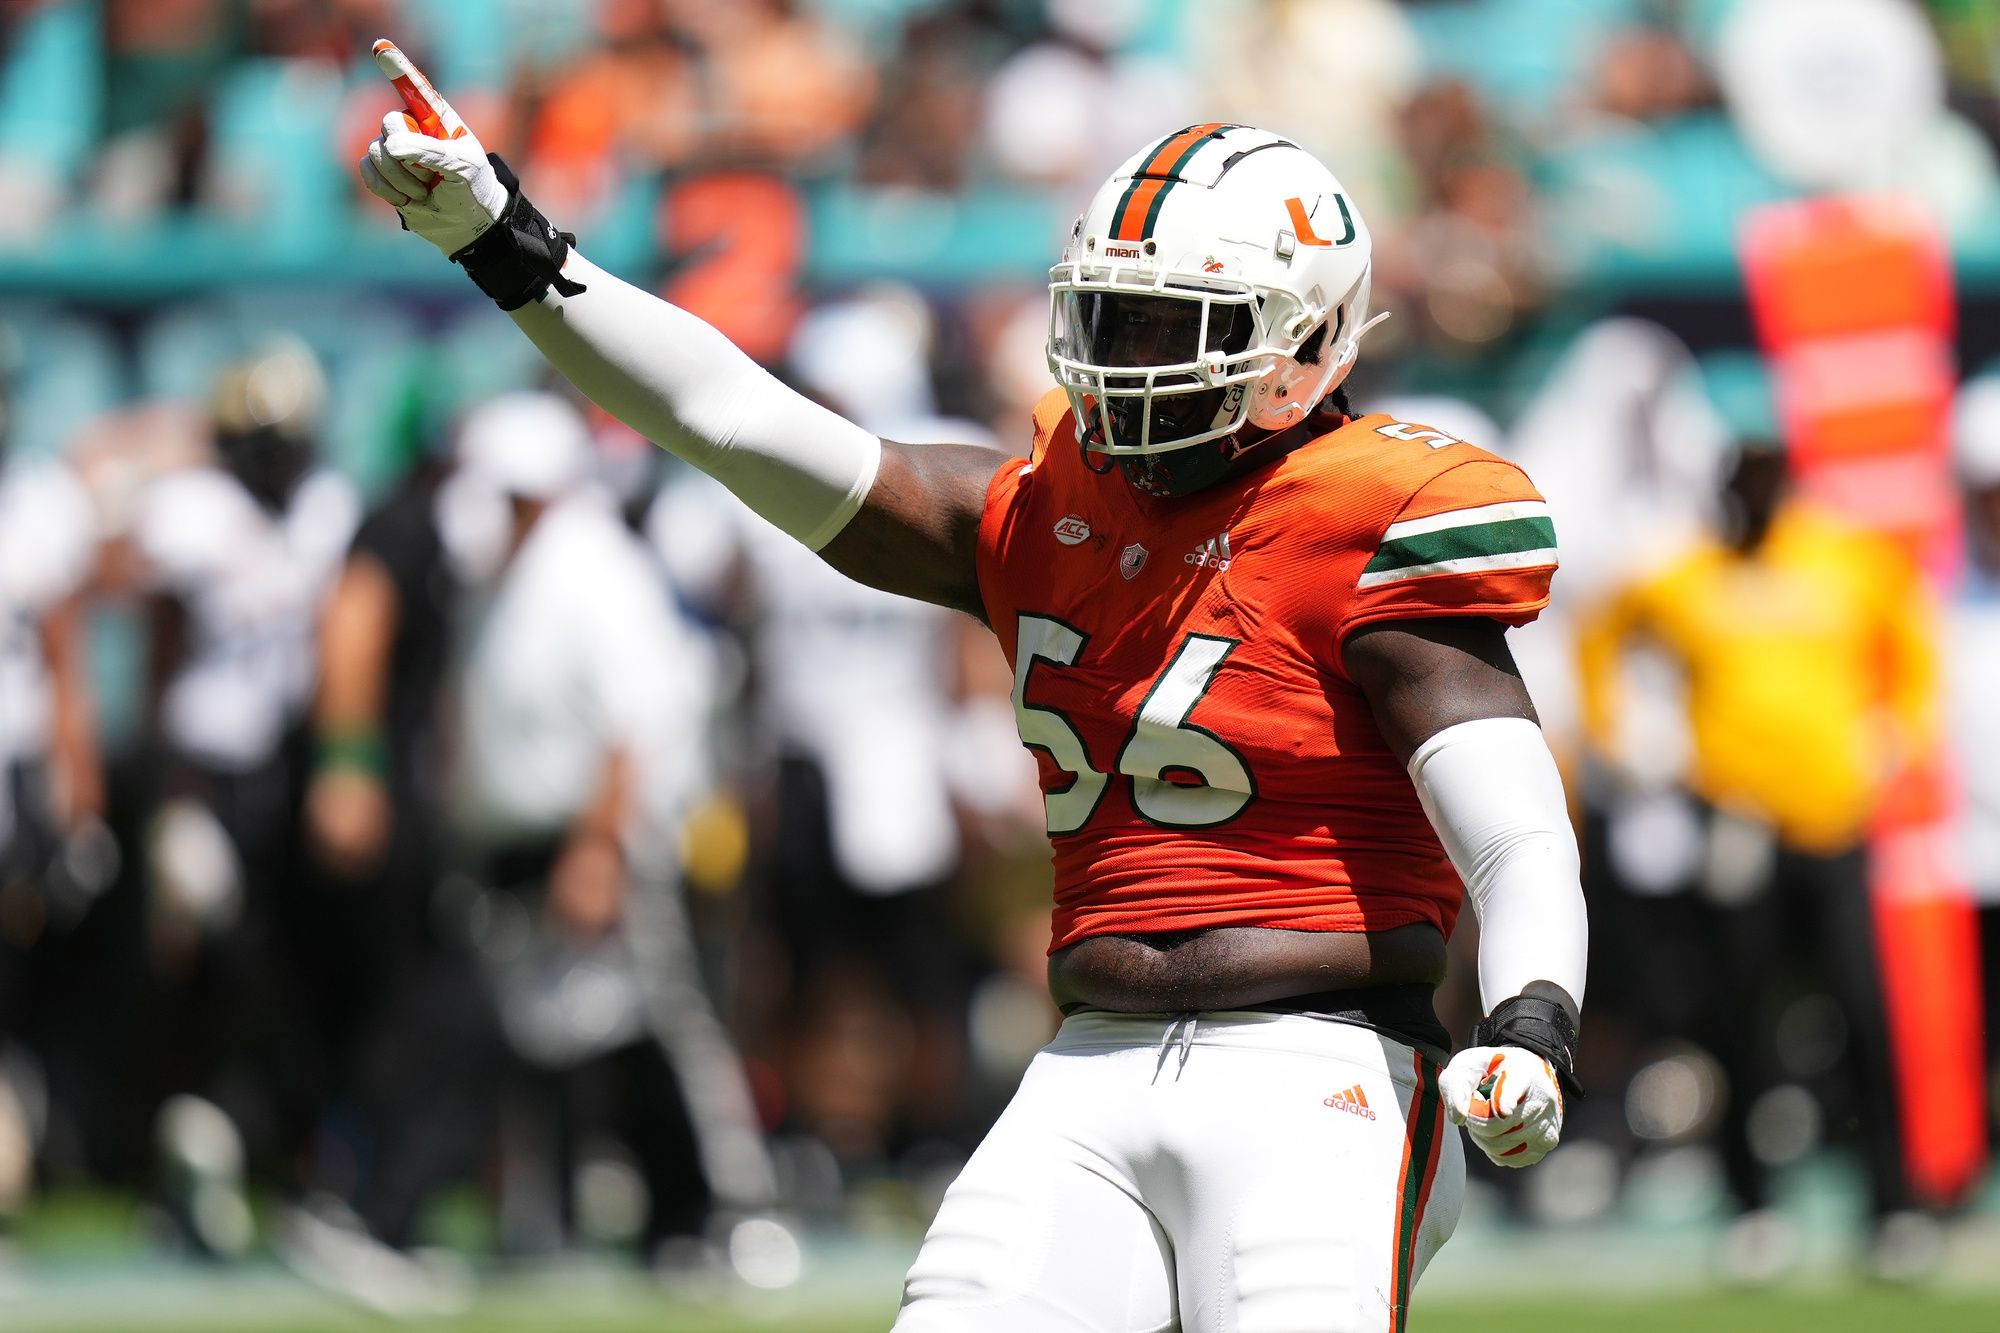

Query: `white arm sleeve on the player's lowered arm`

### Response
(1410, 717, 1590, 1013)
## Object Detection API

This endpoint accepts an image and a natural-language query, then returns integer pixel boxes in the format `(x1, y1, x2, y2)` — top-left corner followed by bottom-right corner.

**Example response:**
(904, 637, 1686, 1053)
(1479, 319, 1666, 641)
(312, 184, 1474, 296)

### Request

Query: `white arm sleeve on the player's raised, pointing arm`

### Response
(514, 250, 882, 550)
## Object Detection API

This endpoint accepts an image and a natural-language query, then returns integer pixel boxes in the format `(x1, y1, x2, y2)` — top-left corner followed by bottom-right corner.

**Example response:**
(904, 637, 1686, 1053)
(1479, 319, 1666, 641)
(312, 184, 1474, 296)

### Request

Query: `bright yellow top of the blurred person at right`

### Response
(1578, 500, 1938, 853)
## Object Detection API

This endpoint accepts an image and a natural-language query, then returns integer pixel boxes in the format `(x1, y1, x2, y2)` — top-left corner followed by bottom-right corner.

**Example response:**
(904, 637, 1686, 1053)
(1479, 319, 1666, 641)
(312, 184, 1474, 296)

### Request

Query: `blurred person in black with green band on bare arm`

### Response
(298, 408, 498, 1263)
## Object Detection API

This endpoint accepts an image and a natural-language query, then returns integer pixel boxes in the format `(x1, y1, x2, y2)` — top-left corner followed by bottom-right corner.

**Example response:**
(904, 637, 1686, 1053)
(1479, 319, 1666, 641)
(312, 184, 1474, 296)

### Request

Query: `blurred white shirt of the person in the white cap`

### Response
(458, 492, 714, 849)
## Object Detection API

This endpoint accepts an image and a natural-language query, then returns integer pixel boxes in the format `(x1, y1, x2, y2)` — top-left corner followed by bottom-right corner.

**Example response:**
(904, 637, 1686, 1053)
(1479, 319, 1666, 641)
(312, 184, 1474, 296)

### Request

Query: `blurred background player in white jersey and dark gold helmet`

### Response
(136, 340, 358, 1253)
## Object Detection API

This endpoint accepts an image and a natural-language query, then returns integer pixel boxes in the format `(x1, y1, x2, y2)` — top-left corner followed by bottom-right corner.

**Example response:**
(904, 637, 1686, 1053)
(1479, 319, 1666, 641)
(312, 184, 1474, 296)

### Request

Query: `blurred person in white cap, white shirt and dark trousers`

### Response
(458, 392, 774, 1251)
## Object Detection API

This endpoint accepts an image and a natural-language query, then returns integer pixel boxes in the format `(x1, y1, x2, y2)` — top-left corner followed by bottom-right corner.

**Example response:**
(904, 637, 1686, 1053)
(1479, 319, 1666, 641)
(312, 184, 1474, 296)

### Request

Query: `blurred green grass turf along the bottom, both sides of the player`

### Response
(15, 1177, 2000, 1333)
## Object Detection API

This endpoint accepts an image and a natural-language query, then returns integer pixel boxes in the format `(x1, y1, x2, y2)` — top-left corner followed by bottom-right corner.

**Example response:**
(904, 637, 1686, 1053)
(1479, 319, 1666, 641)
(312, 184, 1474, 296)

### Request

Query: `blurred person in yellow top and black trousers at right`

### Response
(1580, 374, 1938, 1279)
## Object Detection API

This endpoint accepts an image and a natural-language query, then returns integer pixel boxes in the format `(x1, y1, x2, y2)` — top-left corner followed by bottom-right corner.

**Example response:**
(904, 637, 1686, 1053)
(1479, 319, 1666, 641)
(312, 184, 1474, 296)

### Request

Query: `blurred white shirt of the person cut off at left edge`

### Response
(0, 462, 98, 845)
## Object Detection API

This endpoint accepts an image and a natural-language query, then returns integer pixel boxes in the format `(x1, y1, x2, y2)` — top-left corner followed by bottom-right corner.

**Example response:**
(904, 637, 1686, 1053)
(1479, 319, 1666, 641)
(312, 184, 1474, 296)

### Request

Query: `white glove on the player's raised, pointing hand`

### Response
(360, 40, 508, 256)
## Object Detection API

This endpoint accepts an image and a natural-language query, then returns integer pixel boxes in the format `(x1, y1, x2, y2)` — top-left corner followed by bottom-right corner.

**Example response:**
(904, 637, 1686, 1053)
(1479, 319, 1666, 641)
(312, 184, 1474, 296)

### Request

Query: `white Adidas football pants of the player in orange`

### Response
(896, 1011, 1466, 1333)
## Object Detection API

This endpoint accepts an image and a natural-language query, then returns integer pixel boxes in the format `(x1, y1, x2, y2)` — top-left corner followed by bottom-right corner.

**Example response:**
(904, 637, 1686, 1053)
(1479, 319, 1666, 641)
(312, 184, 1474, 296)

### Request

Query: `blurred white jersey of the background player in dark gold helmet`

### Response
(136, 468, 360, 773)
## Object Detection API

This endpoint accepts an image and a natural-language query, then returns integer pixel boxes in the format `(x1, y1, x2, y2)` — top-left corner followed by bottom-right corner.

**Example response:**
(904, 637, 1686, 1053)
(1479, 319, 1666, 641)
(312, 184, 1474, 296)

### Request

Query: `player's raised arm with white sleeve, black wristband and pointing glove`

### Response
(362, 42, 1006, 614)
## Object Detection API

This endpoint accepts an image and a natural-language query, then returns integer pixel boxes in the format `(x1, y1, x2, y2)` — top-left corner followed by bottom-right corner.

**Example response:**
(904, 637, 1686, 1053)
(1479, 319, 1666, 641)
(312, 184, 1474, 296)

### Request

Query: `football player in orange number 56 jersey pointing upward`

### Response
(362, 44, 1584, 1333)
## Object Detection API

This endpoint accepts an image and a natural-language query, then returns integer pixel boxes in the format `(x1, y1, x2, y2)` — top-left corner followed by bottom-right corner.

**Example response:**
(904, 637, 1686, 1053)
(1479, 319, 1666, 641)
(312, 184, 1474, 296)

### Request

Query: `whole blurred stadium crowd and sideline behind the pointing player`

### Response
(0, 0, 2000, 1333)
